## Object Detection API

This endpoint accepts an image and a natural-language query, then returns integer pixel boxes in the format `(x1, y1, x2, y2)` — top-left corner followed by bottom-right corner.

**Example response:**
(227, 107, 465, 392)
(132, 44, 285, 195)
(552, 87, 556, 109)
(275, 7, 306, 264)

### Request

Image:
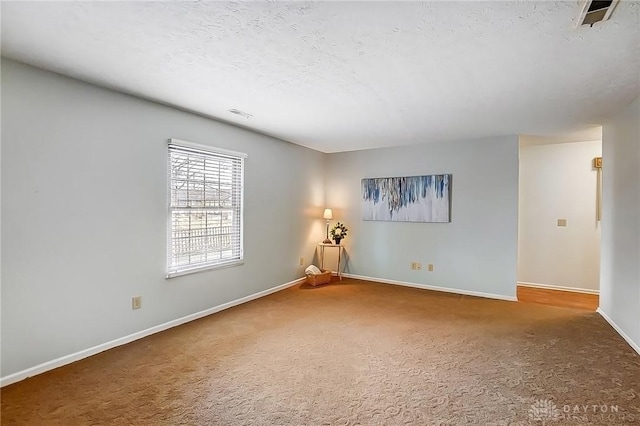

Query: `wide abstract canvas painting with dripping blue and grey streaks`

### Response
(362, 175, 451, 222)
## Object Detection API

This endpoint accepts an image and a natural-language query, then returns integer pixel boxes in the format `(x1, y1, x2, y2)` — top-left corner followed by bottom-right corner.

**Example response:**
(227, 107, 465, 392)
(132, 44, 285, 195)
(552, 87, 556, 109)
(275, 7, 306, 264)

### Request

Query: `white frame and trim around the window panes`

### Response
(166, 138, 247, 279)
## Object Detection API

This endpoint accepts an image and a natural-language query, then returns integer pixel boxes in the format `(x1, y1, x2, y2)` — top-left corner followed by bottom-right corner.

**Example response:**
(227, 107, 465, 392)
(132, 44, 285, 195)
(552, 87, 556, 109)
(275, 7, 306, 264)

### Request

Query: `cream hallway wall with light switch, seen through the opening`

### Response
(518, 138, 602, 291)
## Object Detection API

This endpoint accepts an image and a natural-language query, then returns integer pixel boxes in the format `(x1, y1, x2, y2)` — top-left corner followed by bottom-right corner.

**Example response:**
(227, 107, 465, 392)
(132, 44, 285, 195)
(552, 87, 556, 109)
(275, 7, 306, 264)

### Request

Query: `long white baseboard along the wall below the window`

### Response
(0, 278, 306, 387)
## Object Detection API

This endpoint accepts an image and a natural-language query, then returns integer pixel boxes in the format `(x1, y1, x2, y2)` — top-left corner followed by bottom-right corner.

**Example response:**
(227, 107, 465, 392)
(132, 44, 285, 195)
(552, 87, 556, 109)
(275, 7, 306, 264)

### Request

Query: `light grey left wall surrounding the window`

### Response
(1, 60, 325, 377)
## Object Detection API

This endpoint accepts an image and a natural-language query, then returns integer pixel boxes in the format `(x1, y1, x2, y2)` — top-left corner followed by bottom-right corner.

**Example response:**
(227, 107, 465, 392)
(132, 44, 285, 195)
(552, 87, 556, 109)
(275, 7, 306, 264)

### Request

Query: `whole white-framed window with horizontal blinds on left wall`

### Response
(167, 139, 246, 278)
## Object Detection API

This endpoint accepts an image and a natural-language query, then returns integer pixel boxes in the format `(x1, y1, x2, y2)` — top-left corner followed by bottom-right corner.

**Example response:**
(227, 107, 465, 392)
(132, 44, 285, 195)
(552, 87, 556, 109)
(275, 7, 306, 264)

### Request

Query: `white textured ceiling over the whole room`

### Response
(2, 0, 640, 152)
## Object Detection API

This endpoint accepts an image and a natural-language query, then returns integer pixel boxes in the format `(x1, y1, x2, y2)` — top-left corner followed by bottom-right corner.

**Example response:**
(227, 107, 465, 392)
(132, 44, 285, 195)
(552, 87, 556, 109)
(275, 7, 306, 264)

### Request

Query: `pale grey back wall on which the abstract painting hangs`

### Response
(326, 136, 518, 298)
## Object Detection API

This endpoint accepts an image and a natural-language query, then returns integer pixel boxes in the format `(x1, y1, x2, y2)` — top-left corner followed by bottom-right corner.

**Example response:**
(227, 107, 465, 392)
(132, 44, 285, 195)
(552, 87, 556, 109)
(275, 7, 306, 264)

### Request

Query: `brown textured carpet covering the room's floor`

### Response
(1, 279, 640, 425)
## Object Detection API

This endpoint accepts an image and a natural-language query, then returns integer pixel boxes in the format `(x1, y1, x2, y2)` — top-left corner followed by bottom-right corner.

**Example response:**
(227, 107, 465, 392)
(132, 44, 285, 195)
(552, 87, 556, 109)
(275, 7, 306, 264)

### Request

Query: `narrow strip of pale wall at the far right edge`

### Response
(600, 98, 640, 353)
